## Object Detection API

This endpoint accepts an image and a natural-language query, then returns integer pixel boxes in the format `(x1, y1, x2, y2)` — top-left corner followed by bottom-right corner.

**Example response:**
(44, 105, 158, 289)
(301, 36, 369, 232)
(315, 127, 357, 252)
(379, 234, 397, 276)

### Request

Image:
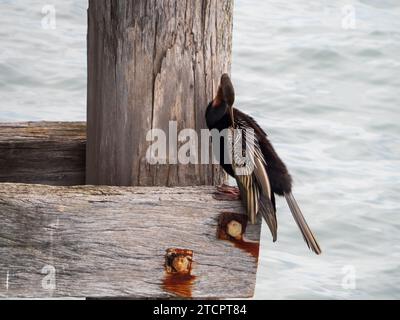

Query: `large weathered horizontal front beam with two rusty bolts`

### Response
(0, 184, 261, 298)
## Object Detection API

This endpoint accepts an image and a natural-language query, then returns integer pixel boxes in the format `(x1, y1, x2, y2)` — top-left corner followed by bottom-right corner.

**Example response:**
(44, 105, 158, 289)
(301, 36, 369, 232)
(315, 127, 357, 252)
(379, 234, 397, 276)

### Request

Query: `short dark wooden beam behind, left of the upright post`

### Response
(0, 122, 86, 185)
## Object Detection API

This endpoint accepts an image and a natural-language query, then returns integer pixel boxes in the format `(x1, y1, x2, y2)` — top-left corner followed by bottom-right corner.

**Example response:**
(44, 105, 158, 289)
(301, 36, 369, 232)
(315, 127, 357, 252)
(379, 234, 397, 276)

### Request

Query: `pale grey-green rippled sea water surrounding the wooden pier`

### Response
(0, 0, 400, 299)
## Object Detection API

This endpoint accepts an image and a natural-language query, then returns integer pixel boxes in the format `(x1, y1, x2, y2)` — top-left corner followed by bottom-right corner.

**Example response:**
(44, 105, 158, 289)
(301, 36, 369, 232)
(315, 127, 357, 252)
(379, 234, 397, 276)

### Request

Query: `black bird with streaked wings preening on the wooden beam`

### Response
(206, 74, 321, 254)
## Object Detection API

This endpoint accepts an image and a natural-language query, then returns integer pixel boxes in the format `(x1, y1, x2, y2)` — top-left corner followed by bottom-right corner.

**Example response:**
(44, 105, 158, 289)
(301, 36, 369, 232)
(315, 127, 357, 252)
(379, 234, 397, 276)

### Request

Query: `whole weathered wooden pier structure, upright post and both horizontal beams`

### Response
(0, 0, 261, 299)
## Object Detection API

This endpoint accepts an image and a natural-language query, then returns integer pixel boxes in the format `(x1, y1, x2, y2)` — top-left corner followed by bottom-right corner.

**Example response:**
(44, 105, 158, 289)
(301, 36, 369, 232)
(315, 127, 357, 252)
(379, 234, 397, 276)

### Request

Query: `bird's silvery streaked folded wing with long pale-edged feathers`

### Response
(232, 115, 277, 241)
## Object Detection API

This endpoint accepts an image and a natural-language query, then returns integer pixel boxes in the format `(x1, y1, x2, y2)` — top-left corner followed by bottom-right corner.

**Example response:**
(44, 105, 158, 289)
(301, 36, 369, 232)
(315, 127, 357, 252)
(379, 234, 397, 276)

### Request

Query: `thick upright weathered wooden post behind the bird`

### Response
(87, 0, 233, 186)
